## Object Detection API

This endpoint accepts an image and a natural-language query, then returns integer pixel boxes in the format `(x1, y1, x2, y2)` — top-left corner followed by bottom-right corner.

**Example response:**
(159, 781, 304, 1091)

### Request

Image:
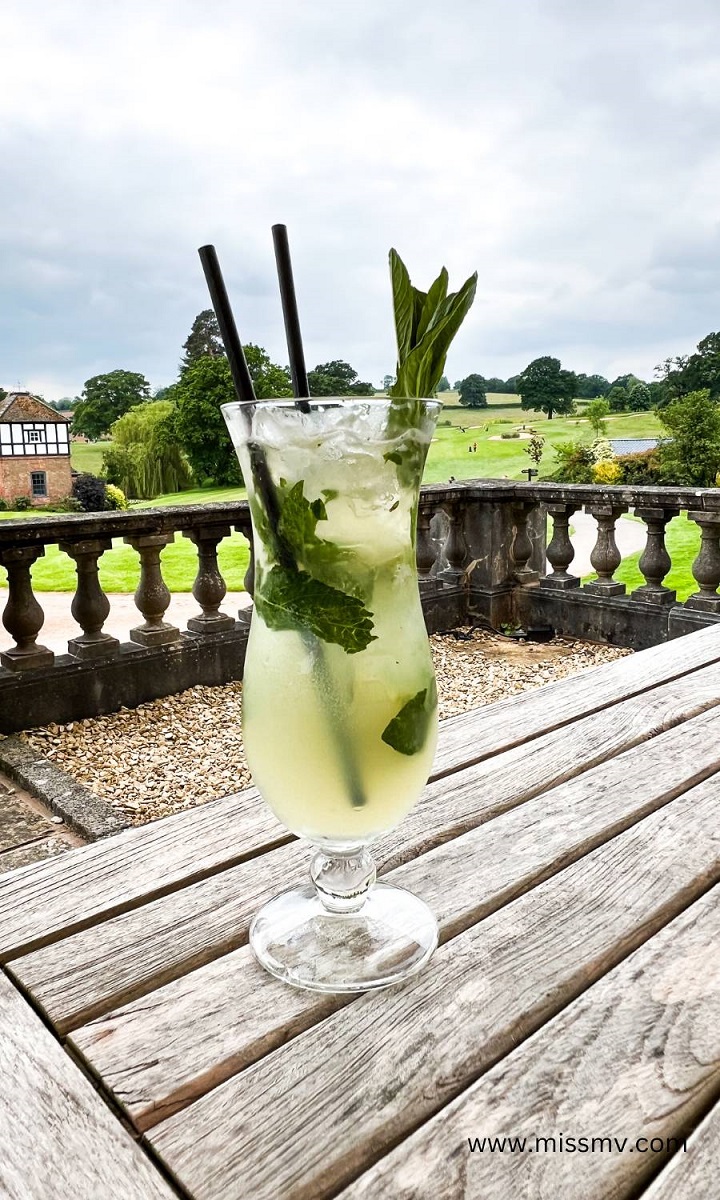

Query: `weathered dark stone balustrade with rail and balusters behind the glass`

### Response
(0, 480, 720, 733)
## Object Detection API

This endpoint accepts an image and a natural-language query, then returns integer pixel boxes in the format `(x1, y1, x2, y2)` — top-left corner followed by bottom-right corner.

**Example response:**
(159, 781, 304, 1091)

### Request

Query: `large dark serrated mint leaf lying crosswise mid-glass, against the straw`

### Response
(254, 566, 376, 654)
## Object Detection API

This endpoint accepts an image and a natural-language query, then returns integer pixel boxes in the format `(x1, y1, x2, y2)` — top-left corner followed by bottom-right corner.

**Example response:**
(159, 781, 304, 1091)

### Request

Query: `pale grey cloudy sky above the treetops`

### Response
(0, 0, 720, 398)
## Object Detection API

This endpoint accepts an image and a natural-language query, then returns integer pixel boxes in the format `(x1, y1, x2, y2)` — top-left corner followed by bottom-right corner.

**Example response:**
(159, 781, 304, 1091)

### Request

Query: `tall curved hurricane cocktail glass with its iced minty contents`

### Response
(223, 398, 442, 992)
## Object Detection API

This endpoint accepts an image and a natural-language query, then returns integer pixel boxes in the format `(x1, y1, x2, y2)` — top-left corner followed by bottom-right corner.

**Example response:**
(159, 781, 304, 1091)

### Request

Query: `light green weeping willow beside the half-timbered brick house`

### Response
(102, 400, 192, 500)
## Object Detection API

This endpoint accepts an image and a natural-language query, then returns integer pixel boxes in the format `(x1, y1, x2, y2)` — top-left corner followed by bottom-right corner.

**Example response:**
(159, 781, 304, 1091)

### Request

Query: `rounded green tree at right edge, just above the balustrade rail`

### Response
(658, 388, 720, 487)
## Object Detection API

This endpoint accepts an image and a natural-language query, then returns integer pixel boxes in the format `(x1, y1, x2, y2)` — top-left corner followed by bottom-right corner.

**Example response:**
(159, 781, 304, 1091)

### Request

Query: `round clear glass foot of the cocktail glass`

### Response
(250, 883, 438, 992)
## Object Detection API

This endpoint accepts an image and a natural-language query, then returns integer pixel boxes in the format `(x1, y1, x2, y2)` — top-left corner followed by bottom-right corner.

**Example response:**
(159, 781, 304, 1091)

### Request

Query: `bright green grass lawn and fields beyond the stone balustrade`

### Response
(0, 405, 700, 600)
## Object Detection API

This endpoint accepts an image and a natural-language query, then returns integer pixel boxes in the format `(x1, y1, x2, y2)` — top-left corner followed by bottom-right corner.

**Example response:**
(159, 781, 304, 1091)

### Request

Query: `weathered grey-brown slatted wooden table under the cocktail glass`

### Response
(0, 628, 720, 1200)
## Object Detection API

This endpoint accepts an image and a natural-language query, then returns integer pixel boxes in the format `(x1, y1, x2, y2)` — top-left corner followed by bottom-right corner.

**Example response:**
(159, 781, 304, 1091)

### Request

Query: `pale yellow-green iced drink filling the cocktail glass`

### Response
(228, 402, 437, 846)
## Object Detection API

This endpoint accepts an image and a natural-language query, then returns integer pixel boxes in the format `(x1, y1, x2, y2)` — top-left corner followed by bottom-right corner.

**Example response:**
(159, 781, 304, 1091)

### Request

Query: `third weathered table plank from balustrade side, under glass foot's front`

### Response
(72, 709, 720, 1129)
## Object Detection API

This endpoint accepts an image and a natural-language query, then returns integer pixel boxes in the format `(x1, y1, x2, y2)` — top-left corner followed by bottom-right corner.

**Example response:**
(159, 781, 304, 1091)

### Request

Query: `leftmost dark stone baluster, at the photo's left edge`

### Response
(0, 546, 55, 671)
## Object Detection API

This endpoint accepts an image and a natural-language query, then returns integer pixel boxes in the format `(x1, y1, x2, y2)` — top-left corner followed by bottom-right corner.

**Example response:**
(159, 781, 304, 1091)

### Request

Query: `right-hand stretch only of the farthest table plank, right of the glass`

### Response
(431, 626, 720, 779)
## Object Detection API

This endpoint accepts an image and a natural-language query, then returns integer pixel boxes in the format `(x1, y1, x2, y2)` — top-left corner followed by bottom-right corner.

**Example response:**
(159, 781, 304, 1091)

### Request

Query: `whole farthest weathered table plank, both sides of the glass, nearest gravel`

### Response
(0, 628, 720, 961)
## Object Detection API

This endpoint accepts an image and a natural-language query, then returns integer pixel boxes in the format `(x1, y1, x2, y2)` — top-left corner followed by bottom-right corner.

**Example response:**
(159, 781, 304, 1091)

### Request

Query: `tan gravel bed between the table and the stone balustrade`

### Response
(20, 629, 631, 824)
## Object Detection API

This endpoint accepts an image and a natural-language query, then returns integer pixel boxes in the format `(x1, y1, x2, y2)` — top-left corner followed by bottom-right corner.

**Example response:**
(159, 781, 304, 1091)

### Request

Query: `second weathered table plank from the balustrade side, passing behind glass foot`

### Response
(12, 664, 720, 1032)
